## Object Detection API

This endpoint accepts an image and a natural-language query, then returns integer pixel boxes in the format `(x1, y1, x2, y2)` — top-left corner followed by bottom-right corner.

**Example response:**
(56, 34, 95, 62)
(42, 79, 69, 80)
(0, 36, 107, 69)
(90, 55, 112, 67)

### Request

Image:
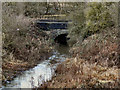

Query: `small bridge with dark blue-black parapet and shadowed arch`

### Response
(36, 20, 71, 44)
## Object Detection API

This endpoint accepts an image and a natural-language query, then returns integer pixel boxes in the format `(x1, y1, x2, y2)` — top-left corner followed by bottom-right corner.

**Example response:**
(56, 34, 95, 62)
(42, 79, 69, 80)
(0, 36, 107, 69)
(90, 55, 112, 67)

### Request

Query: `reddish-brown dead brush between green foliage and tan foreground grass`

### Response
(71, 28, 120, 67)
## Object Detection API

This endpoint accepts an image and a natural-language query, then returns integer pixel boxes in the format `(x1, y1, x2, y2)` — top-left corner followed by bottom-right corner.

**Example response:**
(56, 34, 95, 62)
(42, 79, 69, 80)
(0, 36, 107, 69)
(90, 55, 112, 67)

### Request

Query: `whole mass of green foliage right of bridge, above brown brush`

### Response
(69, 2, 117, 42)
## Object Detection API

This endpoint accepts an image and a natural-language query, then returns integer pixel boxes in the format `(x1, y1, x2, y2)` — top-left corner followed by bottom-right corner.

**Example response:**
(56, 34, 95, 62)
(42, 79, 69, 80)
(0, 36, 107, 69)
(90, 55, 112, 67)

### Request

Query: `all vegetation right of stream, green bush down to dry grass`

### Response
(39, 2, 120, 88)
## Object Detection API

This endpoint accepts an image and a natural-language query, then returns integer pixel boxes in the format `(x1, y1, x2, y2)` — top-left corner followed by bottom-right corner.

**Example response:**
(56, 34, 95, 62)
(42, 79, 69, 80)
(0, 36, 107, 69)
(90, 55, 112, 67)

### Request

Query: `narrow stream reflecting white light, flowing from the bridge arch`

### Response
(2, 45, 69, 90)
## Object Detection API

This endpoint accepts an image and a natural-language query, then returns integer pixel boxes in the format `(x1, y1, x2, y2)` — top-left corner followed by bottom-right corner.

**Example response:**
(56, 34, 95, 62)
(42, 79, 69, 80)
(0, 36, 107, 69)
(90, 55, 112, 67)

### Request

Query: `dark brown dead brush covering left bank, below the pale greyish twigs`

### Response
(2, 18, 51, 84)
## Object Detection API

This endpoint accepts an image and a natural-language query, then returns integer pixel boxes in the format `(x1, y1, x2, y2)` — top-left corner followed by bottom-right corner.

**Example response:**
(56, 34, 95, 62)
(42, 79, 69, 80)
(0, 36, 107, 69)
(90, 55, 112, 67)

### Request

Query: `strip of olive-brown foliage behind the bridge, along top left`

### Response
(3, 2, 63, 18)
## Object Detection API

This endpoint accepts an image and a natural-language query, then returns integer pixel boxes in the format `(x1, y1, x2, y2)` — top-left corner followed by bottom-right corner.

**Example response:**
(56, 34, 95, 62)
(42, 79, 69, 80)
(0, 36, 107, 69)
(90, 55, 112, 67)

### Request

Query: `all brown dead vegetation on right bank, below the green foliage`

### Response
(42, 28, 120, 88)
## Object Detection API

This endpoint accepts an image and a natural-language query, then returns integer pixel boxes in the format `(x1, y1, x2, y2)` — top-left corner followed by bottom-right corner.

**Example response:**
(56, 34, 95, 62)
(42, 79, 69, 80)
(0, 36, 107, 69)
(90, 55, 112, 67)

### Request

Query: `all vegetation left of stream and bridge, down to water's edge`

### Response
(2, 2, 51, 81)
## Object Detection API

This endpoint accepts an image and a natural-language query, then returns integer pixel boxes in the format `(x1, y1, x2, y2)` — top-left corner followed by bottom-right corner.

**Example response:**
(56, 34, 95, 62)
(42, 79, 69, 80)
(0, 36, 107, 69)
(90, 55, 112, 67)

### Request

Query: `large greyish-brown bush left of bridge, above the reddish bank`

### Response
(2, 3, 49, 61)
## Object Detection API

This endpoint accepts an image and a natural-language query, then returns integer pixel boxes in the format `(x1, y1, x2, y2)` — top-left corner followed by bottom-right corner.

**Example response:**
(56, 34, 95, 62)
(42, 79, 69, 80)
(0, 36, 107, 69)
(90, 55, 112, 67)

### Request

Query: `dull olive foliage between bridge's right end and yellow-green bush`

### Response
(69, 3, 85, 36)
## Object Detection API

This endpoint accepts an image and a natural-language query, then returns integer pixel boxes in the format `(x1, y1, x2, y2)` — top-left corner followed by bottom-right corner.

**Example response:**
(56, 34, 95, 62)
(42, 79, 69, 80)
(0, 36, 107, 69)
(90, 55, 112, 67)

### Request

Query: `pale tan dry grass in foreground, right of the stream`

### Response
(43, 58, 120, 88)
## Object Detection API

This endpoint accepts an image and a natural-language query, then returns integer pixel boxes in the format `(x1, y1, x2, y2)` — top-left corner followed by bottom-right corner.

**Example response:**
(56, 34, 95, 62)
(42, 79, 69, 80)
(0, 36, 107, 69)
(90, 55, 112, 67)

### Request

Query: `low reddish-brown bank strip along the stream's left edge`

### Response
(2, 49, 52, 85)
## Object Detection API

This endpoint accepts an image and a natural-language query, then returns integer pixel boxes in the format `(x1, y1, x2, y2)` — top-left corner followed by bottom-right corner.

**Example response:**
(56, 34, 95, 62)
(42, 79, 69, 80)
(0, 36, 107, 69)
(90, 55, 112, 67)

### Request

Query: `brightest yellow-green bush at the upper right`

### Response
(86, 3, 114, 33)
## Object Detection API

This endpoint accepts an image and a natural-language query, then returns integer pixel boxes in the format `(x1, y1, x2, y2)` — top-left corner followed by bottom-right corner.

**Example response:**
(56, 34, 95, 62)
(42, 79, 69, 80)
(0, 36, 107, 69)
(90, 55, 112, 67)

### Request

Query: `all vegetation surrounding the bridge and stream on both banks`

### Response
(2, 2, 120, 88)
